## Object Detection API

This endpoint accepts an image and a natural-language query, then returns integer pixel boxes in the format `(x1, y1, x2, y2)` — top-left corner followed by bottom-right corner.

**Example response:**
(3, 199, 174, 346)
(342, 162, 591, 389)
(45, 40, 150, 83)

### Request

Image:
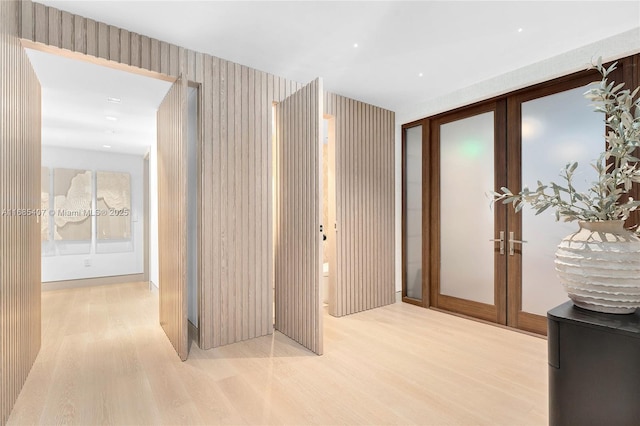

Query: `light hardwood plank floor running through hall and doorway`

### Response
(8, 283, 547, 425)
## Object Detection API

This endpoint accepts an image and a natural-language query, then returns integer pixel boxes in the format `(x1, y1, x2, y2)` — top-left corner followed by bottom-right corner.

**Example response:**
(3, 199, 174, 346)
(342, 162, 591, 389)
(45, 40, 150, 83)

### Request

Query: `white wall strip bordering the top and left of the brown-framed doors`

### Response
(395, 27, 640, 291)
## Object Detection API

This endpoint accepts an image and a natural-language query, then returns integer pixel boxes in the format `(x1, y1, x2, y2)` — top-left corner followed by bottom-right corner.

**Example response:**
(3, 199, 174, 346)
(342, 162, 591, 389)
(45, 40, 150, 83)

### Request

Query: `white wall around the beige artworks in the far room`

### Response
(42, 146, 144, 282)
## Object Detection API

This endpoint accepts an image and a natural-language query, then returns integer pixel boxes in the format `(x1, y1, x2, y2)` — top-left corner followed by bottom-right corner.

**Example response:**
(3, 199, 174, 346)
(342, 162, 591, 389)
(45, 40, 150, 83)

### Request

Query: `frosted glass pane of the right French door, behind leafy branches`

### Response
(521, 86, 604, 316)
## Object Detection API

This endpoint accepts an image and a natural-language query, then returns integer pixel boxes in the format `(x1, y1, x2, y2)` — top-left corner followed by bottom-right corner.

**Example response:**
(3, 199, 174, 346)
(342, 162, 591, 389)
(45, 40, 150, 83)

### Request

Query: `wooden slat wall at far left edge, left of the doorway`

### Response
(0, 1, 41, 424)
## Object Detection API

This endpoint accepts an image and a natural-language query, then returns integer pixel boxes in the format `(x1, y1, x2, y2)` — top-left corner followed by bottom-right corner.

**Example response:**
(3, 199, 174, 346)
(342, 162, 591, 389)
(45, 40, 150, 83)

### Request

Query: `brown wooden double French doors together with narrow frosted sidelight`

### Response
(403, 74, 604, 334)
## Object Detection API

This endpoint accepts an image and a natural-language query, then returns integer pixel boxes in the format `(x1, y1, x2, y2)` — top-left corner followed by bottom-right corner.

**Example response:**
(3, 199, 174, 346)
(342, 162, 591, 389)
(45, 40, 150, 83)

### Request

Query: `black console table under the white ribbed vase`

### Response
(547, 302, 640, 426)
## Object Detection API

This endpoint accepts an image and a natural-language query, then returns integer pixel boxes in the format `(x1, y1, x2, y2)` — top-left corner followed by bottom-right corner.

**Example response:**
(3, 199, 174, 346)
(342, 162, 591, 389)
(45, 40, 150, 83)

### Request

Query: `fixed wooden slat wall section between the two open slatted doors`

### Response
(200, 63, 296, 348)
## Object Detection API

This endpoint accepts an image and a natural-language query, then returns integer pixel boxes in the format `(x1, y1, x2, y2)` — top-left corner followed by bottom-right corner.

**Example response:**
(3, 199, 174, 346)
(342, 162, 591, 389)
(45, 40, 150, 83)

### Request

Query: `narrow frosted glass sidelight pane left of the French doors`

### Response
(403, 126, 423, 300)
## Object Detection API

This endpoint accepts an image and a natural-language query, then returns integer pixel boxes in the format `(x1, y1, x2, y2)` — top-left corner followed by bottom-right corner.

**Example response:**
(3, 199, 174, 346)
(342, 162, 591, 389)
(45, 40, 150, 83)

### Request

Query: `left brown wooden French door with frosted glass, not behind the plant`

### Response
(429, 100, 507, 324)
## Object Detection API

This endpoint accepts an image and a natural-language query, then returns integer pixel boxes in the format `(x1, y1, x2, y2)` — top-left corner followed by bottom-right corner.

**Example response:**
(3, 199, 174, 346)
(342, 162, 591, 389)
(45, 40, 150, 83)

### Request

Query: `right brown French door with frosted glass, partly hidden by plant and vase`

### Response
(505, 75, 605, 334)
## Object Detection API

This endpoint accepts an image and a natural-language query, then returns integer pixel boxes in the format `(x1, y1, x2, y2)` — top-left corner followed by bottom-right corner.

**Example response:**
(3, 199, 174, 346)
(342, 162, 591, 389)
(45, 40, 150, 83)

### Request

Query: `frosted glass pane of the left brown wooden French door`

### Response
(440, 111, 495, 305)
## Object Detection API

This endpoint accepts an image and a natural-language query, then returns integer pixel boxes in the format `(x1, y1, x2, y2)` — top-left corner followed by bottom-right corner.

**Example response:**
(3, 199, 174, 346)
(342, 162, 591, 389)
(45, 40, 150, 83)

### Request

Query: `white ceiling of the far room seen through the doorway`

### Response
(27, 49, 171, 155)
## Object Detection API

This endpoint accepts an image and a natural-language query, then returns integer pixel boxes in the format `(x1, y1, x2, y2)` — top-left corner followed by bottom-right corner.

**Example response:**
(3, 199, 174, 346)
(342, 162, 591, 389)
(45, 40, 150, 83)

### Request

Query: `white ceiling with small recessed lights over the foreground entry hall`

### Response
(28, 0, 640, 155)
